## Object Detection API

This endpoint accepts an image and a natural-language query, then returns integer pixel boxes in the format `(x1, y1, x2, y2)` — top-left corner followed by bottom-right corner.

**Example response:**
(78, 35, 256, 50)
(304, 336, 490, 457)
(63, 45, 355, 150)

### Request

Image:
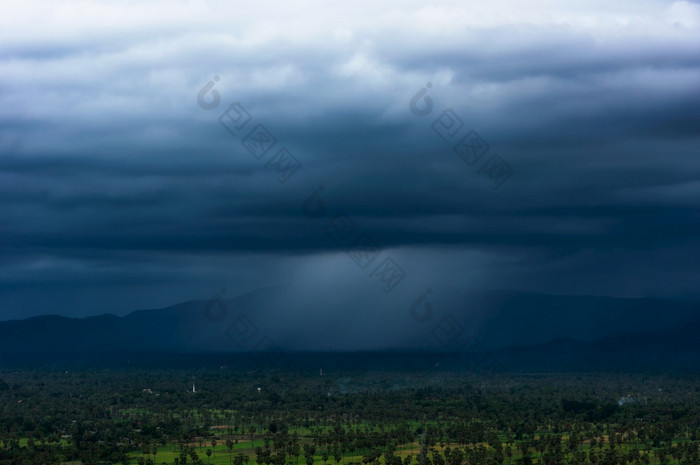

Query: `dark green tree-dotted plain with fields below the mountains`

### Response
(0, 367, 700, 465)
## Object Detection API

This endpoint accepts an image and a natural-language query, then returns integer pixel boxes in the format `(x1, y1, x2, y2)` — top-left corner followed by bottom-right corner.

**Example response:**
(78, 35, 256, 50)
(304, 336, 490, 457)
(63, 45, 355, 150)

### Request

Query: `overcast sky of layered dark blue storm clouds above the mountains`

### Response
(0, 0, 700, 319)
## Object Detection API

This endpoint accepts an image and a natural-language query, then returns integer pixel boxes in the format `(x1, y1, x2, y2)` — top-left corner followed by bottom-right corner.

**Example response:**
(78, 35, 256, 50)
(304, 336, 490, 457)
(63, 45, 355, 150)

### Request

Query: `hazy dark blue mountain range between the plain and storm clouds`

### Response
(0, 286, 700, 369)
